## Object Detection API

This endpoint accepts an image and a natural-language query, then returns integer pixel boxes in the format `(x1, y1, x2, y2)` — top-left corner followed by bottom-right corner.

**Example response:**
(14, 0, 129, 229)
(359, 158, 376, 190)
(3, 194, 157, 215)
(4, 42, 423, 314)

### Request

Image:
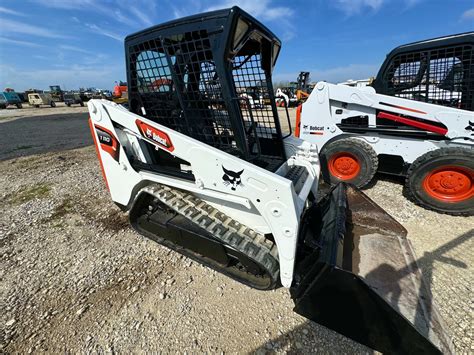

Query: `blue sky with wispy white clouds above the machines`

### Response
(0, 0, 474, 91)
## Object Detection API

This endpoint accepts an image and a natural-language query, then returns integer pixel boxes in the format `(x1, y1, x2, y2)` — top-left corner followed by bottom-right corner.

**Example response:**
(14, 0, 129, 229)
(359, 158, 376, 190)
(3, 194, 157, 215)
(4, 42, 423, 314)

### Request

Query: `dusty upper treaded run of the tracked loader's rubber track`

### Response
(143, 184, 280, 284)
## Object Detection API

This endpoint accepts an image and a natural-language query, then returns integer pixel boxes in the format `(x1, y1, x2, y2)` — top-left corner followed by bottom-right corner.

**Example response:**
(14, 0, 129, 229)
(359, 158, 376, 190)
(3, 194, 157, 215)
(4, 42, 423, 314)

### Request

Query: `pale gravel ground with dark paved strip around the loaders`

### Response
(0, 107, 474, 353)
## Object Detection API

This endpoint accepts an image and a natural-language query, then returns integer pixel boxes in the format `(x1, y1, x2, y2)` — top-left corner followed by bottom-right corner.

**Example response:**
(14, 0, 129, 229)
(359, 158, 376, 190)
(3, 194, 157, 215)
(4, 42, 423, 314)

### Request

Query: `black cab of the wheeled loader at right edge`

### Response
(372, 32, 474, 111)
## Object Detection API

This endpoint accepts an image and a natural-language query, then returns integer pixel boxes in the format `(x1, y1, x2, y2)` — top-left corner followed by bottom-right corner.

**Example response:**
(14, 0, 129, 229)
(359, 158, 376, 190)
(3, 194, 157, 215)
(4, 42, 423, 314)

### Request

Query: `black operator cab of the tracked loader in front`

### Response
(125, 7, 286, 175)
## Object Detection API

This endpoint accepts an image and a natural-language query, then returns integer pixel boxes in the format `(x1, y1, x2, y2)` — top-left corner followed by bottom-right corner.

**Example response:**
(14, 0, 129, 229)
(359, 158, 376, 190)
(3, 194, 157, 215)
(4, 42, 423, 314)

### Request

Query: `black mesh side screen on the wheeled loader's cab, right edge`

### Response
(384, 46, 474, 111)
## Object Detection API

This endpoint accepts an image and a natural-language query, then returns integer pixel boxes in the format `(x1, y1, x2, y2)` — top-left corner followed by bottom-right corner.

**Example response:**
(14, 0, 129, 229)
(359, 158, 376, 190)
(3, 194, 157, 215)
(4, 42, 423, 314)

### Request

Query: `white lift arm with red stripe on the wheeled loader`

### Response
(301, 82, 474, 140)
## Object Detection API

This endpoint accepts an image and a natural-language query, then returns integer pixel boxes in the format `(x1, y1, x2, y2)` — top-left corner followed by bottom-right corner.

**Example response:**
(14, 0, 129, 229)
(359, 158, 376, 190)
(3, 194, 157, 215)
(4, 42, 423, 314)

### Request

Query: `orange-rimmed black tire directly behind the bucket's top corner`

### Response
(319, 138, 379, 188)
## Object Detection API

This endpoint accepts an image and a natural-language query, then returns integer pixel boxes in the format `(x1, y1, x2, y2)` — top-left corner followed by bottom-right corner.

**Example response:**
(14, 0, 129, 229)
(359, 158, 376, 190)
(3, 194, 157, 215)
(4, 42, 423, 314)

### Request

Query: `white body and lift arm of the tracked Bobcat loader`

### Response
(88, 100, 320, 287)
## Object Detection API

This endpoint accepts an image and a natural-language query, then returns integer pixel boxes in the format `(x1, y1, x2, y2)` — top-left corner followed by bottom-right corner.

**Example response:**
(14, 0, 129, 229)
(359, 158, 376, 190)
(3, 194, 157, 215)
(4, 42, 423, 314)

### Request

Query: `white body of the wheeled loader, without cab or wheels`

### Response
(299, 82, 474, 164)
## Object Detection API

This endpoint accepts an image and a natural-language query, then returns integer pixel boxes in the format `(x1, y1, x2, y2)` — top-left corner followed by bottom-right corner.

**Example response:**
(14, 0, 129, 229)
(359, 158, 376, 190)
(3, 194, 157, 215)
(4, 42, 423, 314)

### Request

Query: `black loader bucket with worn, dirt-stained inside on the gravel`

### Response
(291, 183, 452, 354)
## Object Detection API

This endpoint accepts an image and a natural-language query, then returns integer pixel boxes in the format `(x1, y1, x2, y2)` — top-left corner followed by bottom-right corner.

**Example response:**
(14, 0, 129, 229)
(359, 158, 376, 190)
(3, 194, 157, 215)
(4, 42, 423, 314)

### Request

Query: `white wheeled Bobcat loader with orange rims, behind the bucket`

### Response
(295, 32, 474, 215)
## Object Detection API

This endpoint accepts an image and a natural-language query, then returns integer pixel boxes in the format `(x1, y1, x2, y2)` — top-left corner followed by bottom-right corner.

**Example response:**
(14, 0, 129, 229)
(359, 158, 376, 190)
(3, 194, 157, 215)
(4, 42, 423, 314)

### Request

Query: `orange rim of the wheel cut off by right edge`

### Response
(423, 166, 474, 202)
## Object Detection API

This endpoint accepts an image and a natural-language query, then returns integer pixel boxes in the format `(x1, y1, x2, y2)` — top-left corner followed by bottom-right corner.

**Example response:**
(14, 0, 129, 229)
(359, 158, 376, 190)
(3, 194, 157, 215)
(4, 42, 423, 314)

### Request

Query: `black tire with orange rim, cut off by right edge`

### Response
(404, 148, 474, 216)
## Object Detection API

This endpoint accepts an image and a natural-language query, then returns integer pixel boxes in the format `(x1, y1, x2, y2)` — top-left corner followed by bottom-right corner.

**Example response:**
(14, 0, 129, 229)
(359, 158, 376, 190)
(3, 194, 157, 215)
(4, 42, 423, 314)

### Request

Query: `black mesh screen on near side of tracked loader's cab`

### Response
(129, 31, 239, 155)
